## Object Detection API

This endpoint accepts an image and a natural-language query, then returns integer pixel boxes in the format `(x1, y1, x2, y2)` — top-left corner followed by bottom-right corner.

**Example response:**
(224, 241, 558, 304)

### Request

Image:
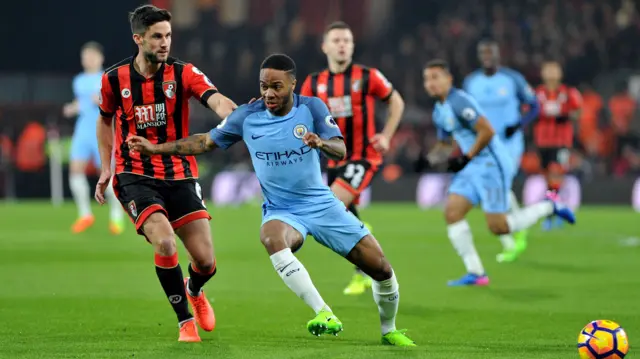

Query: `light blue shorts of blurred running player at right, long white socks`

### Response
(449, 164, 513, 213)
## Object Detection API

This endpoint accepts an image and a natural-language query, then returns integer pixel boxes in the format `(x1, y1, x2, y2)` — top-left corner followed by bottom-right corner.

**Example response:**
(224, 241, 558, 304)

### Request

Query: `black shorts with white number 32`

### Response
(327, 160, 378, 197)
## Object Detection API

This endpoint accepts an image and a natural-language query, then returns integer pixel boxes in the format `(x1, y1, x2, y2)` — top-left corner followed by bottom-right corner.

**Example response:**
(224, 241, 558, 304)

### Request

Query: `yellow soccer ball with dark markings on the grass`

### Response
(578, 320, 629, 359)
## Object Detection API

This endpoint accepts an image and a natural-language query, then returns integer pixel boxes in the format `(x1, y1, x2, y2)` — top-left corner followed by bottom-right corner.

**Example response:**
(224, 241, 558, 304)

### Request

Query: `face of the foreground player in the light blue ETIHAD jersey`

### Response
(260, 69, 296, 114)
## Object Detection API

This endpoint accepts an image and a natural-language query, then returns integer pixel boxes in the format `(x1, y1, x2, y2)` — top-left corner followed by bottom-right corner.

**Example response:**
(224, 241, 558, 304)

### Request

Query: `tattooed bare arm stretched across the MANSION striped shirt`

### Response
(127, 133, 216, 156)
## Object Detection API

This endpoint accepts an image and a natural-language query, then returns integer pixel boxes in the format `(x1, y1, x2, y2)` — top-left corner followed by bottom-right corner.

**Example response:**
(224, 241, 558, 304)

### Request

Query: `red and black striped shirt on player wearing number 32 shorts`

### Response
(300, 64, 393, 167)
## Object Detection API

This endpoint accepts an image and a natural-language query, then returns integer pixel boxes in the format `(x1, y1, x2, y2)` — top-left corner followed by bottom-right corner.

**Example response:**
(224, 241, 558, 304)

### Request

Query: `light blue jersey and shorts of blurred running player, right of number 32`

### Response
(433, 88, 515, 213)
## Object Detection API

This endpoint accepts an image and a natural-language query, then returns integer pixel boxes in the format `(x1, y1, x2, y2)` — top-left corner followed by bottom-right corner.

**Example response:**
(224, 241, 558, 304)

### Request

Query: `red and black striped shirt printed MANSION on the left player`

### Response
(100, 56, 218, 180)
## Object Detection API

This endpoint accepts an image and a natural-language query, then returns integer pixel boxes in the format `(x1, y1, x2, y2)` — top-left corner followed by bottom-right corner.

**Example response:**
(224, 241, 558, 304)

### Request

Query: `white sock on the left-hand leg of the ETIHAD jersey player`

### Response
(271, 248, 331, 314)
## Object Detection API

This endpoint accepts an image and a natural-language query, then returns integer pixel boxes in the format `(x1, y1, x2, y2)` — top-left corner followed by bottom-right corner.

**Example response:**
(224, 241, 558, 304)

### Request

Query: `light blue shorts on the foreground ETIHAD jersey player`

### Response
(262, 199, 371, 257)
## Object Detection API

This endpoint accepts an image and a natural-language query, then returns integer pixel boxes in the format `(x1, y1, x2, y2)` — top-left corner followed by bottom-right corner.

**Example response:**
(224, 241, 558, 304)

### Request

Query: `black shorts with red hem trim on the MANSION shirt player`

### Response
(112, 173, 211, 235)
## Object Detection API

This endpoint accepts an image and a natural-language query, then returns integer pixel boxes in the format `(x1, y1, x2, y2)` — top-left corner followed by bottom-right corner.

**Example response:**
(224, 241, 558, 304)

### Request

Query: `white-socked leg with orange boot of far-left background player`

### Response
(69, 160, 95, 233)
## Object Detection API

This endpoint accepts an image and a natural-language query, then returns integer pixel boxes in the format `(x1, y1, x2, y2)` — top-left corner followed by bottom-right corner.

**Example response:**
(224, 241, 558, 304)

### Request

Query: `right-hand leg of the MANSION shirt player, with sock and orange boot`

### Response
(176, 219, 216, 332)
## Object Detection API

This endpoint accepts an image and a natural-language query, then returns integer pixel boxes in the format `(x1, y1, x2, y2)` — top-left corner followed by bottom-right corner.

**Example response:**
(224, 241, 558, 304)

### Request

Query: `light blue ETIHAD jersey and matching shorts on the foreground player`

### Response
(210, 95, 369, 256)
